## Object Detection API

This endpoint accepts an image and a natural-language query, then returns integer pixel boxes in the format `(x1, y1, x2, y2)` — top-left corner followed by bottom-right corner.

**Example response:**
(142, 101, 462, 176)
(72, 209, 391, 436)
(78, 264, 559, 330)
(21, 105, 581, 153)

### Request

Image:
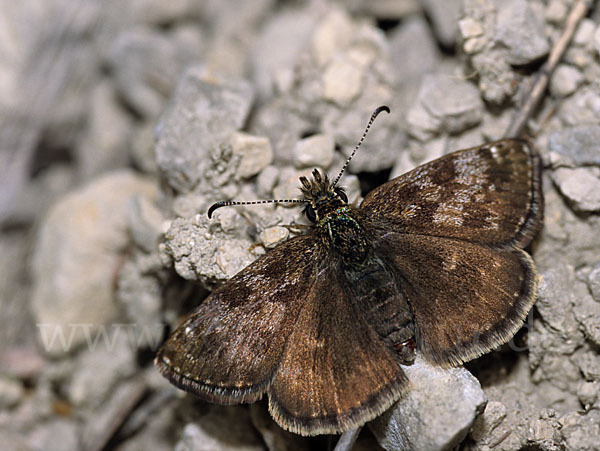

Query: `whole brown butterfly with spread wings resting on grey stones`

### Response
(155, 107, 543, 435)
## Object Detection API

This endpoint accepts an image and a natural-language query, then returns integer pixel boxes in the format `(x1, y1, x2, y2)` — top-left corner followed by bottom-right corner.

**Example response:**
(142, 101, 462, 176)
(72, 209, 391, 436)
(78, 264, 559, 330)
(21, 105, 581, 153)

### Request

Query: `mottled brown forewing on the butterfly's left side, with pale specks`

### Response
(155, 235, 318, 404)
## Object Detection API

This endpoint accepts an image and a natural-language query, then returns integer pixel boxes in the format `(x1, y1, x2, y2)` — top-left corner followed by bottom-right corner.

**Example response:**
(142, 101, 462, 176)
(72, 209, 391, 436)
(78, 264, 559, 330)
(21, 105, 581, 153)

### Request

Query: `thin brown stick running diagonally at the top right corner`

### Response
(504, 0, 594, 138)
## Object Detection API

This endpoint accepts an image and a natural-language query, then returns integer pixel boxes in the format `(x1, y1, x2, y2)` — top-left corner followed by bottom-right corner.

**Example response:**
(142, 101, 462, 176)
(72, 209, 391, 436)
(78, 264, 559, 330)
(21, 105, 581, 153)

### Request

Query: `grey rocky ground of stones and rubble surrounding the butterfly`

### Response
(0, 0, 600, 451)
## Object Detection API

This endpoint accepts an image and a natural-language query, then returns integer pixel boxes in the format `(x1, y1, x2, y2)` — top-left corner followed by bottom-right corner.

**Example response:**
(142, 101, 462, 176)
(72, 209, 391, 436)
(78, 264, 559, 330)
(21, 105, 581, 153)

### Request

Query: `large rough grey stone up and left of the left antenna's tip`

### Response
(156, 66, 253, 192)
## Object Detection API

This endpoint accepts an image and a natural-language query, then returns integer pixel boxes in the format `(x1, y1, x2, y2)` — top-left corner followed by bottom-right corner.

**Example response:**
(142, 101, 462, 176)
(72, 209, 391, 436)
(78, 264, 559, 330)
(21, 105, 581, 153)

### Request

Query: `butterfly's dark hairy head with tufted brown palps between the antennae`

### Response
(300, 169, 348, 222)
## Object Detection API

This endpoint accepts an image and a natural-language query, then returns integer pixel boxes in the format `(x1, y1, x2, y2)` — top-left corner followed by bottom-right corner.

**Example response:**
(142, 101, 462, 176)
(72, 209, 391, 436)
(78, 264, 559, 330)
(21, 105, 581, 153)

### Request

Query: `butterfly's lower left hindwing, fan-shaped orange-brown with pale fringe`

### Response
(268, 261, 408, 435)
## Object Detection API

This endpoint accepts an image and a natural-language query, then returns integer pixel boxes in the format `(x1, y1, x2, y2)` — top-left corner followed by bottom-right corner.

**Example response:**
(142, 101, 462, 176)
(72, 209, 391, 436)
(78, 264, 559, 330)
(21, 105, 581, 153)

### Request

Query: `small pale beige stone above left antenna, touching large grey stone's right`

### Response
(231, 132, 273, 178)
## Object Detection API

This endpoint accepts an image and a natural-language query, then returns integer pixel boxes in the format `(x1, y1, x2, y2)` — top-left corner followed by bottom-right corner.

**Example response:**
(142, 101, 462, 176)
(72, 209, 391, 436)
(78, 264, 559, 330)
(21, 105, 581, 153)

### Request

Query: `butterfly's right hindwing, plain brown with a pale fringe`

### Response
(376, 233, 536, 366)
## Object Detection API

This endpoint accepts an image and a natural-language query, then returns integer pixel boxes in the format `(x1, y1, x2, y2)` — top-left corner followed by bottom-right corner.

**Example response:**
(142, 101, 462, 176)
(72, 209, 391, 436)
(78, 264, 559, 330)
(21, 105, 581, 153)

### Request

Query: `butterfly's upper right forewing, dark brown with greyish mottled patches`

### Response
(361, 139, 543, 247)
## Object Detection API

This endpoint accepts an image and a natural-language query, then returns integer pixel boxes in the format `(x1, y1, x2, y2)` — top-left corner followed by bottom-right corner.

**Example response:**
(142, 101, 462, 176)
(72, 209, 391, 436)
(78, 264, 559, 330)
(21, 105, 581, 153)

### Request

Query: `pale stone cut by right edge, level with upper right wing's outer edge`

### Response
(552, 167, 600, 212)
